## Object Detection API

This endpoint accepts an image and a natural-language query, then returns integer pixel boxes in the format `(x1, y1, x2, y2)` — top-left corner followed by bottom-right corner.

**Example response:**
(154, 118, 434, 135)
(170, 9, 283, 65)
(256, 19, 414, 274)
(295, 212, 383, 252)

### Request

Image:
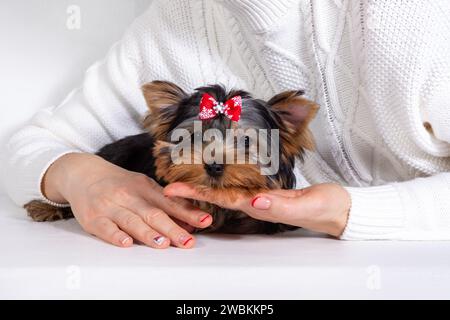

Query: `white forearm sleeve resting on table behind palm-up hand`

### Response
(341, 173, 450, 240)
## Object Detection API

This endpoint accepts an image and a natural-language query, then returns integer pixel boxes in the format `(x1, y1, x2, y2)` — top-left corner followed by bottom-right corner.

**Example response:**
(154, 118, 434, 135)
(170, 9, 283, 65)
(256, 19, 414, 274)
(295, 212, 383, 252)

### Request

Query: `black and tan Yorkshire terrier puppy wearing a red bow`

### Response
(25, 81, 318, 234)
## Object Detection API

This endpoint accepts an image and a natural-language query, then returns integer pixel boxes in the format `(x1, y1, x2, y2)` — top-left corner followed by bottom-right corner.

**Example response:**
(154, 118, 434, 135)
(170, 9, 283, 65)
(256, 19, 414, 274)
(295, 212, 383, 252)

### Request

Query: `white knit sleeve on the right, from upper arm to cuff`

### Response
(341, 1, 450, 240)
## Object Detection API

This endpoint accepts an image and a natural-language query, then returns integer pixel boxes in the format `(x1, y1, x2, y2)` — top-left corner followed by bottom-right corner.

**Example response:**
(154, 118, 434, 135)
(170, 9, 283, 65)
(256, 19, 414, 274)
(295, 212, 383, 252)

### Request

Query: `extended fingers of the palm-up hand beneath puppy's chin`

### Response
(164, 182, 238, 209)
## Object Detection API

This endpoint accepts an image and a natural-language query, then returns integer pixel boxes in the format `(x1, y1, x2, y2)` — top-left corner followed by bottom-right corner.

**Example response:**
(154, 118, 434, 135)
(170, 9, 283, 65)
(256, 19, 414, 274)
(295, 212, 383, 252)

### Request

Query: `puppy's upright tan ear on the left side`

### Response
(142, 81, 187, 140)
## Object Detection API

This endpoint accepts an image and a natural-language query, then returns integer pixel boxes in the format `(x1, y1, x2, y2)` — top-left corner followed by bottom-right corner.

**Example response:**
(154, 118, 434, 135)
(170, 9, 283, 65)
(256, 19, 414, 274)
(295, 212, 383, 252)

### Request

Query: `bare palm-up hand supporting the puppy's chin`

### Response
(164, 183, 351, 237)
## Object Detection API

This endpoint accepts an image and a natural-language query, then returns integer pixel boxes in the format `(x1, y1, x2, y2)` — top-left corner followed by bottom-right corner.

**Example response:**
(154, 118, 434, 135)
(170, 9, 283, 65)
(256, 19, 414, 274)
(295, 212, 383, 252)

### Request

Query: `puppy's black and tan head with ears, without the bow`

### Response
(143, 81, 318, 194)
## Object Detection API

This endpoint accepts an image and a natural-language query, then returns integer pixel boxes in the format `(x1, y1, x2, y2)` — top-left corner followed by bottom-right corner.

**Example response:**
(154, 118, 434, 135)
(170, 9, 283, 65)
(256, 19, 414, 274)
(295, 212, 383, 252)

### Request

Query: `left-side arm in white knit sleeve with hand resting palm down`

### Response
(4, 0, 212, 248)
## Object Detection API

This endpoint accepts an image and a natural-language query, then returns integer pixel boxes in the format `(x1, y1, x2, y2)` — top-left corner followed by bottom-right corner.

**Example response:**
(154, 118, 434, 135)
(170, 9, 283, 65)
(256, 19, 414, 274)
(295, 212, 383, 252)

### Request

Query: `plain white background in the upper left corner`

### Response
(0, 0, 151, 190)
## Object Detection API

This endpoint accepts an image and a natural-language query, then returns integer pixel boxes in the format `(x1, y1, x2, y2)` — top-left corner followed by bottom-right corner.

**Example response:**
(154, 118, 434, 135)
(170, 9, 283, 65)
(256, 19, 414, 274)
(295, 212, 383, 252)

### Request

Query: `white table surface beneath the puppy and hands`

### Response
(0, 195, 450, 299)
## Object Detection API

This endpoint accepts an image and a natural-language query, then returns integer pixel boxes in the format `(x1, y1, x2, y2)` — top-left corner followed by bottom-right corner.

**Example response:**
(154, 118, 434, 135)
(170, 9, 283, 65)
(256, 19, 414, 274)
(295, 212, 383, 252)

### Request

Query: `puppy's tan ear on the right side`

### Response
(268, 91, 319, 154)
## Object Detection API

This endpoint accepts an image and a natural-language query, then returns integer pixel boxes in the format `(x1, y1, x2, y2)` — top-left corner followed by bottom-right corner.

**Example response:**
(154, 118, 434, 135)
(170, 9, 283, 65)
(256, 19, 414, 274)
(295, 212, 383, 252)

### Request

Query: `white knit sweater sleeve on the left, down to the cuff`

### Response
(3, 0, 201, 205)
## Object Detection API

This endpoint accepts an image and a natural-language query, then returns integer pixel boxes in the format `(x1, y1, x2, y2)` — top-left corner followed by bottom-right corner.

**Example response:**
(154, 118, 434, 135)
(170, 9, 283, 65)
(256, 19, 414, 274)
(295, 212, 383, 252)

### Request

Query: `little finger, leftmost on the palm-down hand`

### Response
(86, 217, 133, 248)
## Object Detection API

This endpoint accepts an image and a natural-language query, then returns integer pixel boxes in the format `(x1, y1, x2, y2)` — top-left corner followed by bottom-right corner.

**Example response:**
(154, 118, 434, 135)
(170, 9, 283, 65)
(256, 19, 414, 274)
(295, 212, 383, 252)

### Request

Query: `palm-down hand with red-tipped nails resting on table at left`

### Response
(43, 154, 212, 249)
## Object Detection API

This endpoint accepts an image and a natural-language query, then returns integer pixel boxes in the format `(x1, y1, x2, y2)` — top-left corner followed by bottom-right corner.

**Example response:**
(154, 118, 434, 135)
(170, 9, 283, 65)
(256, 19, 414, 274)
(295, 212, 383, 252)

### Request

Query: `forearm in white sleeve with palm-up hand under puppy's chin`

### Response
(164, 173, 450, 240)
